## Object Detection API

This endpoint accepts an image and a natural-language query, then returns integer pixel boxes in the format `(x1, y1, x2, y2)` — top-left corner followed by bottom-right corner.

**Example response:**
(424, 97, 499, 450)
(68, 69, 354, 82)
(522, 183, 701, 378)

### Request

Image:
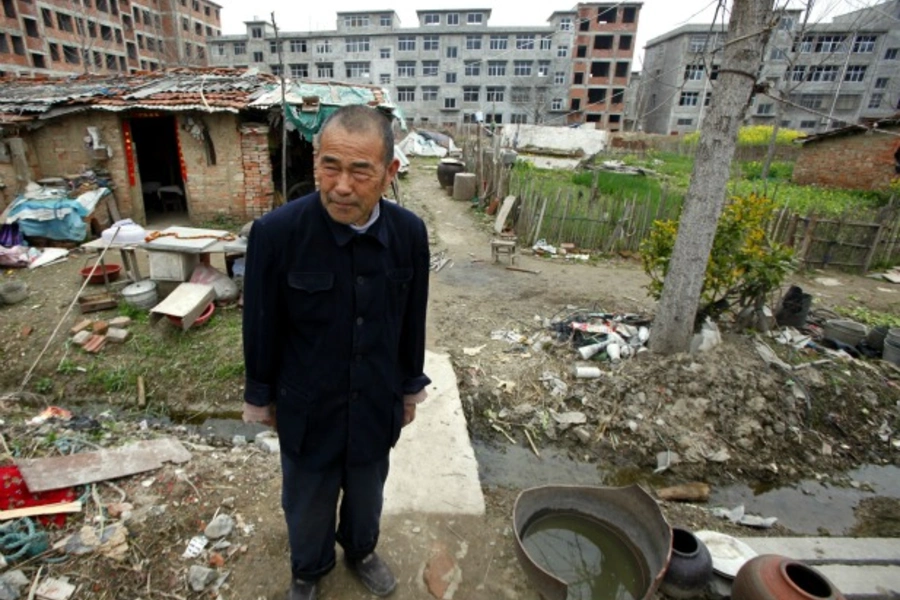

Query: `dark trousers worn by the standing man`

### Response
(281, 445, 390, 581)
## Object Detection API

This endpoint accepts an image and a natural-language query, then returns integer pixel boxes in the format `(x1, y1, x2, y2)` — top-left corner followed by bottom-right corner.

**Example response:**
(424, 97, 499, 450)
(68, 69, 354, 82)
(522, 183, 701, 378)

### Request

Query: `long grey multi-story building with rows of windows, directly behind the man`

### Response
(210, 3, 636, 126)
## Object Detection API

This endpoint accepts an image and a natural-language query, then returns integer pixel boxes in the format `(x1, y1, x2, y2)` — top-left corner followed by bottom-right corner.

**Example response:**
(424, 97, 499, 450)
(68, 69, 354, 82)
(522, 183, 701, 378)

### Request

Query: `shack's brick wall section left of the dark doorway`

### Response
(30, 111, 134, 216)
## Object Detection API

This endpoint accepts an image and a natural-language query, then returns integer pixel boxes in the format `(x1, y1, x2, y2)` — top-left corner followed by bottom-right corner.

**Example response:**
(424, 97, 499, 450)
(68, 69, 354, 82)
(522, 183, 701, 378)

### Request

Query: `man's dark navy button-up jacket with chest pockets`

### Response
(243, 192, 431, 469)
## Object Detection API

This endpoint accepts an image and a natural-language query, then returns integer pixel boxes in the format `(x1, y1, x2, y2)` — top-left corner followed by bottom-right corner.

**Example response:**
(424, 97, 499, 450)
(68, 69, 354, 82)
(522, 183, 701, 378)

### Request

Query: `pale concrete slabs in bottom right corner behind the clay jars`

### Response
(741, 538, 900, 600)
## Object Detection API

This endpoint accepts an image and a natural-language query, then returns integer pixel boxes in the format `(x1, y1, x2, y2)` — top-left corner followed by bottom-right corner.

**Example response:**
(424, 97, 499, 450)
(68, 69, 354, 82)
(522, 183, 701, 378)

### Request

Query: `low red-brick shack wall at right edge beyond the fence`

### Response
(793, 127, 900, 190)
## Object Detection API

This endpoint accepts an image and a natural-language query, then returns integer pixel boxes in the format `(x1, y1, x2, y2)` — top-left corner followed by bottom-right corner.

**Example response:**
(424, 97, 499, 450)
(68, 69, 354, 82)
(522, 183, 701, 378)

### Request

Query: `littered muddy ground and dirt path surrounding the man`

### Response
(0, 157, 900, 599)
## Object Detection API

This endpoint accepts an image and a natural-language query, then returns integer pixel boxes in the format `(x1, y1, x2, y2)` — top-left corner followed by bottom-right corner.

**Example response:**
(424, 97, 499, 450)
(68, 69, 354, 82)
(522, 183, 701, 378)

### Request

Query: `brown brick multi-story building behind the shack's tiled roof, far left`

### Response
(0, 0, 222, 76)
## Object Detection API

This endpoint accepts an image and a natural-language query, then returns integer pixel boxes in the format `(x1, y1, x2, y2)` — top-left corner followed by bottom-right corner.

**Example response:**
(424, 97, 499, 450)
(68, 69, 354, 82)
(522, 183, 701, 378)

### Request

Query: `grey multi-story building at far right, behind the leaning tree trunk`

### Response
(634, 0, 900, 133)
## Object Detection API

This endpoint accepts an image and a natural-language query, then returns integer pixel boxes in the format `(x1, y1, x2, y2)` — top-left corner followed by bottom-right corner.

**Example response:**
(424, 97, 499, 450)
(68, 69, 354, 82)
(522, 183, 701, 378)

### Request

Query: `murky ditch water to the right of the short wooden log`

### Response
(710, 465, 900, 535)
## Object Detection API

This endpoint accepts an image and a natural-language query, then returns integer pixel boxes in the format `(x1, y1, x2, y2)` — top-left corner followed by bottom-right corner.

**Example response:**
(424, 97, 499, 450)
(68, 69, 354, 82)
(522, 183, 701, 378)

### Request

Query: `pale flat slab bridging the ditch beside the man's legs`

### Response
(384, 351, 484, 515)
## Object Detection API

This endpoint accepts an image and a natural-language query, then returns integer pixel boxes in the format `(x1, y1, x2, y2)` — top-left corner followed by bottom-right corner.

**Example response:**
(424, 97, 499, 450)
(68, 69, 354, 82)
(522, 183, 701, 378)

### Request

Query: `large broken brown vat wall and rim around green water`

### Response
(513, 485, 672, 600)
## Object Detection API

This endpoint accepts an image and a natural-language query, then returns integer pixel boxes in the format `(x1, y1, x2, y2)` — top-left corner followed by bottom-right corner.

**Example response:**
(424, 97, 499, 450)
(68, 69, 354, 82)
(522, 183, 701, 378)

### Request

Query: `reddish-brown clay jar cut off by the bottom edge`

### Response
(731, 554, 844, 600)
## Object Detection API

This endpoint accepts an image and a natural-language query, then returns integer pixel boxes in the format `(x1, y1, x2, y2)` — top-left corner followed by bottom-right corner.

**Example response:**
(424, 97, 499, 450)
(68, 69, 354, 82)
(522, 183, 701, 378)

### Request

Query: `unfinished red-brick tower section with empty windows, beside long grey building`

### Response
(569, 2, 641, 131)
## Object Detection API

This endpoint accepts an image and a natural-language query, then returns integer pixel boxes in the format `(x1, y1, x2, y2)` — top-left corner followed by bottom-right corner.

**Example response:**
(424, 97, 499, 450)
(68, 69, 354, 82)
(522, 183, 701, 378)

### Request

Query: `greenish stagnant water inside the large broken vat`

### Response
(522, 512, 647, 600)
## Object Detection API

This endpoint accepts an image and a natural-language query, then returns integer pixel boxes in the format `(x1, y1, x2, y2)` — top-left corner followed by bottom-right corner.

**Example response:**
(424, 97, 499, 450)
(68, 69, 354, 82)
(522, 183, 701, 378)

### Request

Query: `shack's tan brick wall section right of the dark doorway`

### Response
(177, 113, 244, 221)
